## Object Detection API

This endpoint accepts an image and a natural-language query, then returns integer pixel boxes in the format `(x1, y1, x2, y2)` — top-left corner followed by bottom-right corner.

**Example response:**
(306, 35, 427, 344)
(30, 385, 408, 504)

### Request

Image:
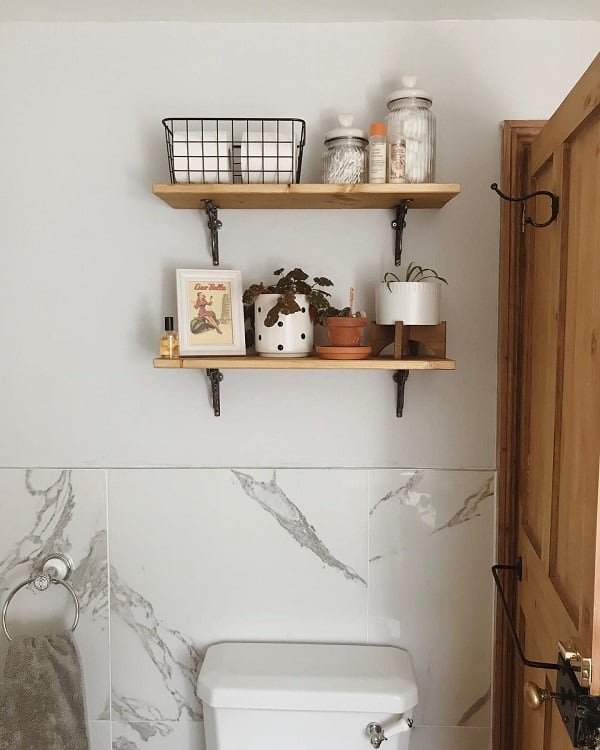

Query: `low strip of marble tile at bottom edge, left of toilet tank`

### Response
(112, 721, 204, 750)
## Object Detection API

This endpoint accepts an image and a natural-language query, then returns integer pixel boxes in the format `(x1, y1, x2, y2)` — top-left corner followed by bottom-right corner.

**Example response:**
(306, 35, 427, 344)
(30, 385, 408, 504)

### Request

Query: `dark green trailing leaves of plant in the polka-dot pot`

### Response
(242, 268, 339, 327)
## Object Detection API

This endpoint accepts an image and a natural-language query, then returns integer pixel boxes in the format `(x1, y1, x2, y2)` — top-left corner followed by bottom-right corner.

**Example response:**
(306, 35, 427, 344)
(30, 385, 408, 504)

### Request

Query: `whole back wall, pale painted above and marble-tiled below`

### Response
(0, 22, 600, 750)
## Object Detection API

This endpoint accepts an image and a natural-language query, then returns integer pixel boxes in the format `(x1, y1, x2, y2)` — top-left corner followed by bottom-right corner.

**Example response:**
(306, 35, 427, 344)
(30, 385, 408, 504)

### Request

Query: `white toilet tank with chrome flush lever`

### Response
(198, 643, 419, 750)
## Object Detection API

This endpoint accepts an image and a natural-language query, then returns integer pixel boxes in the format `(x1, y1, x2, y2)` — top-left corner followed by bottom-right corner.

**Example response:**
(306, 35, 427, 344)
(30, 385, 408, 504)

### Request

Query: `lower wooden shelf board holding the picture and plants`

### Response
(154, 355, 456, 370)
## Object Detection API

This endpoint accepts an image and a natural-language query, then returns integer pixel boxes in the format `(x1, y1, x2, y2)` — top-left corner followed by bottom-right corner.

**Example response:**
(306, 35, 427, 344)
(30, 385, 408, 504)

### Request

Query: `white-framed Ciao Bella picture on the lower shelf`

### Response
(177, 268, 246, 357)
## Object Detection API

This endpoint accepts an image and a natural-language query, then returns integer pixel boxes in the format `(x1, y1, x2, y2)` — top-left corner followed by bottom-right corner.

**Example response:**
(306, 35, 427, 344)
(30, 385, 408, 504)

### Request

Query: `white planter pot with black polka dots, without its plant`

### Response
(254, 294, 314, 357)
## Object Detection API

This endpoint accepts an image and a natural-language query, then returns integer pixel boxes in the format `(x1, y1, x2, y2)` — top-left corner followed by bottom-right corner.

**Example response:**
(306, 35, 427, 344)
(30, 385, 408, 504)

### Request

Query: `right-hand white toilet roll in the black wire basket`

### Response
(240, 130, 297, 184)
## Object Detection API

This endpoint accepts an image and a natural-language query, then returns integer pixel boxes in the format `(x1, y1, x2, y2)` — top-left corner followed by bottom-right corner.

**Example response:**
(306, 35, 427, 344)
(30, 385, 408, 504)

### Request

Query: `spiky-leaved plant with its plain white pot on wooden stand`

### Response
(375, 263, 448, 325)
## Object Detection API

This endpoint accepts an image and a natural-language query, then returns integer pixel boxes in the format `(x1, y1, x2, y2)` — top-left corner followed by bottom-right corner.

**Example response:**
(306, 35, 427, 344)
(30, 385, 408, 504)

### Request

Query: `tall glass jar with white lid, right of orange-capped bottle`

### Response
(386, 76, 435, 182)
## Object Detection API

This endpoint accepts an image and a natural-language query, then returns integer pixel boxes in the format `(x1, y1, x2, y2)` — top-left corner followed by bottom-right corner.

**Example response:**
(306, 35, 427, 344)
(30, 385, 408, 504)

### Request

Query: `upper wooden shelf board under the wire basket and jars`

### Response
(152, 183, 460, 209)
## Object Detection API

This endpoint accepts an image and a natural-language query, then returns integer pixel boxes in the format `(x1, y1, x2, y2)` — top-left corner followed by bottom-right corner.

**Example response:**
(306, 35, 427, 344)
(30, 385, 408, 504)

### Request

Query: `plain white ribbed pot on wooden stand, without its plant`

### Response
(375, 281, 442, 326)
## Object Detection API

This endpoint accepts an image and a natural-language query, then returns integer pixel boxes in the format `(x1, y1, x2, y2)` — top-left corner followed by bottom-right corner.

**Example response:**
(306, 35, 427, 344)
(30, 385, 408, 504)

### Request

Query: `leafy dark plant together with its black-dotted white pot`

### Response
(242, 268, 337, 357)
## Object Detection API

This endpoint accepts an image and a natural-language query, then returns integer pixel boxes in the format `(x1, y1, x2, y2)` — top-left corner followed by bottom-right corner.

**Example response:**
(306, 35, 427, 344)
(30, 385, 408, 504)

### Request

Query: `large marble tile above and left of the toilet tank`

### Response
(109, 469, 368, 724)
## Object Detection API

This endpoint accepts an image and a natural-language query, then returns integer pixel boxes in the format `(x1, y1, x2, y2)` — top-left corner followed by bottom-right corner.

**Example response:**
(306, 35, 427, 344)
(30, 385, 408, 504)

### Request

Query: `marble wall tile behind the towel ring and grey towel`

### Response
(0, 469, 110, 721)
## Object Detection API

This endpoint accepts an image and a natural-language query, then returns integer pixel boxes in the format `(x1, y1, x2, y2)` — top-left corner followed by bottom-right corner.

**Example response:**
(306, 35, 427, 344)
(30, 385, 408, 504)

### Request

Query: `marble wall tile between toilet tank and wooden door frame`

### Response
(369, 470, 494, 727)
